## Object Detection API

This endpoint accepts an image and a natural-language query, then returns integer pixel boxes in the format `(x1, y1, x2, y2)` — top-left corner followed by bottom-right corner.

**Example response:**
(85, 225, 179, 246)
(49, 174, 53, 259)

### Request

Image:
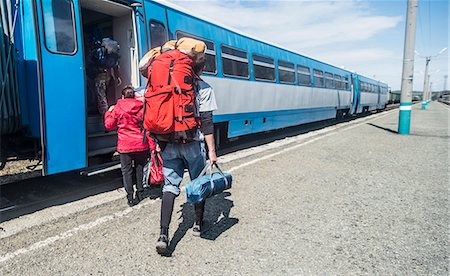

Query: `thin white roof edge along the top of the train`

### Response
(153, 0, 387, 85)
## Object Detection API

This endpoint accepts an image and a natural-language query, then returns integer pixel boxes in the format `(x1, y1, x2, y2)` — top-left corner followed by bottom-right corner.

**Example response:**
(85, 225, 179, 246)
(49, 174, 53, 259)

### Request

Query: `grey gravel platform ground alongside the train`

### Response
(0, 103, 450, 275)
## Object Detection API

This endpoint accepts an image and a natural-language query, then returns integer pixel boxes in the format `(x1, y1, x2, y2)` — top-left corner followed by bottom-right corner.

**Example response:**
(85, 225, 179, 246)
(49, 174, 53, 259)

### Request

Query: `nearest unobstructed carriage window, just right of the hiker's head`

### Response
(220, 45, 249, 78)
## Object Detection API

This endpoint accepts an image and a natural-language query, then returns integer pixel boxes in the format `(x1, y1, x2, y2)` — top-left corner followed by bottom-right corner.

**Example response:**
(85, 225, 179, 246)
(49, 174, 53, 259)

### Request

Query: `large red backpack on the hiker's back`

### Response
(144, 50, 198, 143)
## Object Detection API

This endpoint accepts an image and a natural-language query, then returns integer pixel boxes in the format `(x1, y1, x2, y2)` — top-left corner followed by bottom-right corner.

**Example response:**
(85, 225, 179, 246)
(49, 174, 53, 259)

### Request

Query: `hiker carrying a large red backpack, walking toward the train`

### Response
(144, 37, 217, 254)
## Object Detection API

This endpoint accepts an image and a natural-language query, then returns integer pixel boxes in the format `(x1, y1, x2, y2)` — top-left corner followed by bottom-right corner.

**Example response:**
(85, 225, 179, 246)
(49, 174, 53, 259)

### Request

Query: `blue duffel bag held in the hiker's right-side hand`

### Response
(186, 163, 232, 204)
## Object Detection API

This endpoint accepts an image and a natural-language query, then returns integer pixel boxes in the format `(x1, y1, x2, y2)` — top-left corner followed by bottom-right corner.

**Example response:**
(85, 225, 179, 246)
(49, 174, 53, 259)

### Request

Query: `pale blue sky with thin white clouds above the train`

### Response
(171, 0, 450, 91)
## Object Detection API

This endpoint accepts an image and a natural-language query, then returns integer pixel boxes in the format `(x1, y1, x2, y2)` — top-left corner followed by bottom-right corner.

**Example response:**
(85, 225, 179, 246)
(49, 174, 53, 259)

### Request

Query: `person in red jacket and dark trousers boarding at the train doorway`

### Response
(105, 86, 156, 206)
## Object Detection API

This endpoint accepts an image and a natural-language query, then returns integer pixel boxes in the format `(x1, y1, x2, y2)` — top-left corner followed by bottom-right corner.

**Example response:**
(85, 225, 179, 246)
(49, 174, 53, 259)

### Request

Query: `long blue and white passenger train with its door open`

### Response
(0, 0, 389, 175)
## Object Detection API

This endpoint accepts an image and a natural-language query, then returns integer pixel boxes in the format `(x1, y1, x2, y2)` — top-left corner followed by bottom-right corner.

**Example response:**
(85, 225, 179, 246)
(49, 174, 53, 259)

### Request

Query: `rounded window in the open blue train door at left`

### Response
(42, 0, 77, 55)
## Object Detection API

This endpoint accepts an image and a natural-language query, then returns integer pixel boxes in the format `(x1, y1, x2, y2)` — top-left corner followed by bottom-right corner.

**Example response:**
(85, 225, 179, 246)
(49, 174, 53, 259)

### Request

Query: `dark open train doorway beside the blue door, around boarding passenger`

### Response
(80, 0, 139, 163)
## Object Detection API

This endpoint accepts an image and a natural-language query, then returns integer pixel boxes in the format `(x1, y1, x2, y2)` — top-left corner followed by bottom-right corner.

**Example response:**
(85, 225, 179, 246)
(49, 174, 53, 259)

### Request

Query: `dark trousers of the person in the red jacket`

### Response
(120, 151, 148, 195)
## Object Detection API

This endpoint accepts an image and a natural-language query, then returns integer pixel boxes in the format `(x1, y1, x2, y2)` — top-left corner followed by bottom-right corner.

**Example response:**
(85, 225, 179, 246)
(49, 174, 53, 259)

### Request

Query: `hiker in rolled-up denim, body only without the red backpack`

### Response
(156, 63, 217, 254)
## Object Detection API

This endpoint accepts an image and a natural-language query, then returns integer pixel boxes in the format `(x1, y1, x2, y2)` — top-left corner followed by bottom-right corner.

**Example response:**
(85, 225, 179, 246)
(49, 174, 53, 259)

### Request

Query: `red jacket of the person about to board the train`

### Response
(105, 98, 156, 153)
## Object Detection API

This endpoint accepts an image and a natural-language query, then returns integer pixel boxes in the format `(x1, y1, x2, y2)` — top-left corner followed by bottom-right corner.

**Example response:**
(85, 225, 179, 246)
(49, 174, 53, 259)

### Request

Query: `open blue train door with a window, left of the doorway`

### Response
(35, 0, 87, 175)
